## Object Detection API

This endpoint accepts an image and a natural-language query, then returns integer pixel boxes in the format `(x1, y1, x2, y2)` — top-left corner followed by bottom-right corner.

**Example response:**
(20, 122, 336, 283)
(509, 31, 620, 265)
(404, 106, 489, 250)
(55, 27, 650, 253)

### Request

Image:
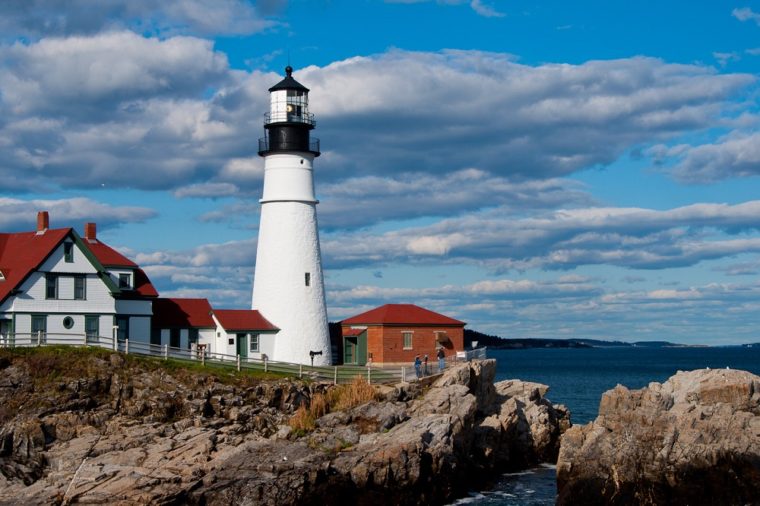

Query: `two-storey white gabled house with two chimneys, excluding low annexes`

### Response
(0, 211, 158, 342)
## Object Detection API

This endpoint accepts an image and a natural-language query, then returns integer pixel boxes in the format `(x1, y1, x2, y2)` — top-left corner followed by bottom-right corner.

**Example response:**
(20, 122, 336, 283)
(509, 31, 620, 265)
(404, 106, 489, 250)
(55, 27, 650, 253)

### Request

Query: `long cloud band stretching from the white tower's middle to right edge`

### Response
(322, 201, 760, 271)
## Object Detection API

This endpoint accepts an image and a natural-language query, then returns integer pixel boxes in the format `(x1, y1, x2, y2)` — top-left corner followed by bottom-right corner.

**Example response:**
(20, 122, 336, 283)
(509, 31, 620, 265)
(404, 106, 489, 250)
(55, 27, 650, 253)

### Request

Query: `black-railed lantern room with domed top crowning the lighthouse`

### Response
(259, 65, 319, 156)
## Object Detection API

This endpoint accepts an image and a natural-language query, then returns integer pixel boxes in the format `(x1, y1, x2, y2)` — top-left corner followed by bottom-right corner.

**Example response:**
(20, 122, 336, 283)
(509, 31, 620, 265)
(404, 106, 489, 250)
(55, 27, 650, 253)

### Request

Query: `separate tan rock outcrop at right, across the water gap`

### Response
(557, 369, 760, 505)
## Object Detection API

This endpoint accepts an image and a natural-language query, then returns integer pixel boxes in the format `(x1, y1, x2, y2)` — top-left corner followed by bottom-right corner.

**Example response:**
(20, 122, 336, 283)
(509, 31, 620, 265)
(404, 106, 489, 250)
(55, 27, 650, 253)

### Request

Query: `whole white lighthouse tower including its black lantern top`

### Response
(251, 66, 331, 365)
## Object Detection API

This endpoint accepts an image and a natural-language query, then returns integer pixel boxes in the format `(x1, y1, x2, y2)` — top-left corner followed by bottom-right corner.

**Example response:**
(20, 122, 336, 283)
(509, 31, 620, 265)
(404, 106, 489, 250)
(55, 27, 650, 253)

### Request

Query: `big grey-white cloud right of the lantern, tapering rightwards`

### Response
(299, 51, 754, 178)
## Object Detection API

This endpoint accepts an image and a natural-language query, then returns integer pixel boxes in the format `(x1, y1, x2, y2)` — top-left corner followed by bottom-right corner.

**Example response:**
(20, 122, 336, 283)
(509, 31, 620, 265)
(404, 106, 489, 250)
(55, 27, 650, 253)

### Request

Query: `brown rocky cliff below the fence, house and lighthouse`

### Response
(0, 351, 569, 505)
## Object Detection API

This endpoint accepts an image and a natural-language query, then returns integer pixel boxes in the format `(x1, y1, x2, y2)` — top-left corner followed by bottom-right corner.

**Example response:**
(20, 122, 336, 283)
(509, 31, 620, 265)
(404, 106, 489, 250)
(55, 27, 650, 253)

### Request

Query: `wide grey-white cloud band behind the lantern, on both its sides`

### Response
(0, 47, 754, 195)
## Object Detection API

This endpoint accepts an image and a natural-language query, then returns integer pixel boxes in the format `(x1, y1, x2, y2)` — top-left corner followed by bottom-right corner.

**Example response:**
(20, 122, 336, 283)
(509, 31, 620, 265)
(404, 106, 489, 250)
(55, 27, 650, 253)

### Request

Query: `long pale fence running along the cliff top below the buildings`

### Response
(0, 332, 486, 385)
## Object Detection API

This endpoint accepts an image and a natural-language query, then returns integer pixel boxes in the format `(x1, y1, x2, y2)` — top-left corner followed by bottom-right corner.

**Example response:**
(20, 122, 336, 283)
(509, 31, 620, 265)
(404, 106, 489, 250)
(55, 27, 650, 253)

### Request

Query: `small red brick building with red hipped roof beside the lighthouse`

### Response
(341, 304, 465, 365)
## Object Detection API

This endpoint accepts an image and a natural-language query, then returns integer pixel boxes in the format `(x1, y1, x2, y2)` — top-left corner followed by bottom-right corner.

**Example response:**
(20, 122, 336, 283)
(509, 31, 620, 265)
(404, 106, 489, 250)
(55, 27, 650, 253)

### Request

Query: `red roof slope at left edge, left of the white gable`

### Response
(0, 228, 71, 302)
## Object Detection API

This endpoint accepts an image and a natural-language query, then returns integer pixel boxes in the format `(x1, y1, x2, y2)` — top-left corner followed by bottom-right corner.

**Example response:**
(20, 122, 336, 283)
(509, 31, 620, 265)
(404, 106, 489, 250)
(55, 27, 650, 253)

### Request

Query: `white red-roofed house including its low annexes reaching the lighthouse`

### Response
(0, 211, 278, 359)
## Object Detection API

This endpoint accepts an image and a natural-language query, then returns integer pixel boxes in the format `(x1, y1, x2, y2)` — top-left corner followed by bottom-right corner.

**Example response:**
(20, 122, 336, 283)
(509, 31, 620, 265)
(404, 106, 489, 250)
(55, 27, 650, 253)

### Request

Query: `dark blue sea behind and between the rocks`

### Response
(456, 346, 760, 506)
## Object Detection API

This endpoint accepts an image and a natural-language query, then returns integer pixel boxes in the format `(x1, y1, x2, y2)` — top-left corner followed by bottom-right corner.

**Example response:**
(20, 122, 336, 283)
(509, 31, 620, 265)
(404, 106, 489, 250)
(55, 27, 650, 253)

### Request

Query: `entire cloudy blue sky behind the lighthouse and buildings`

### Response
(0, 0, 760, 344)
